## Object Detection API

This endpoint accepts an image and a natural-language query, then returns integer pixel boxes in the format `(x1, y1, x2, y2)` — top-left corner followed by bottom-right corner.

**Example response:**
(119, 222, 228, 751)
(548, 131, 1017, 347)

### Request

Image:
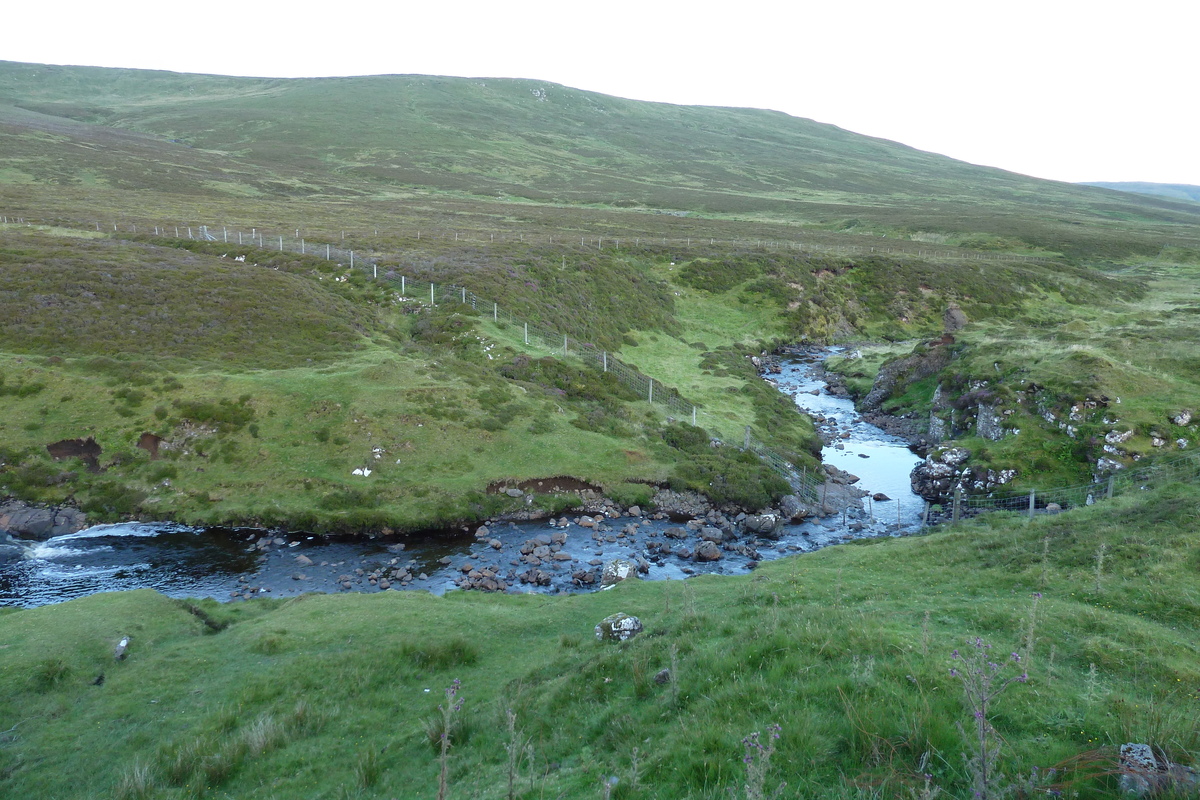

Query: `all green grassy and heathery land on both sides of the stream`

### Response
(0, 62, 1200, 798)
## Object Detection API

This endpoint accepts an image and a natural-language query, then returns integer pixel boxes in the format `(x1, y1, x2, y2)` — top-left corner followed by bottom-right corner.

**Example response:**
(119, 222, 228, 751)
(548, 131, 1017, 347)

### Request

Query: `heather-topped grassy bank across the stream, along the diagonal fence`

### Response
(0, 225, 816, 530)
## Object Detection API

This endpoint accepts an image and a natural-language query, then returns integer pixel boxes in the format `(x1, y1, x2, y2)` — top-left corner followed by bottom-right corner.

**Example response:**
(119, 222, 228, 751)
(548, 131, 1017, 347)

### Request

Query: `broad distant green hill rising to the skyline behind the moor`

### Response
(7, 62, 1200, 258)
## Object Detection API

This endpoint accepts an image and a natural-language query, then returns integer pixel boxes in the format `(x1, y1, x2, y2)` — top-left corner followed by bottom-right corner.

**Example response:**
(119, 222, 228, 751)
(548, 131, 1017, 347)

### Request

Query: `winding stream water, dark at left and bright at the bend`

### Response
(0, 347, 923, 607)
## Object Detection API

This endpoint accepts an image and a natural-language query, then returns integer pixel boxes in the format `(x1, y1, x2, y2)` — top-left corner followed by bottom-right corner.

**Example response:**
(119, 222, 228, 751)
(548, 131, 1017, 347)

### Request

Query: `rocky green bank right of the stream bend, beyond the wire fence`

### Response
(832, 261, 1200, 491)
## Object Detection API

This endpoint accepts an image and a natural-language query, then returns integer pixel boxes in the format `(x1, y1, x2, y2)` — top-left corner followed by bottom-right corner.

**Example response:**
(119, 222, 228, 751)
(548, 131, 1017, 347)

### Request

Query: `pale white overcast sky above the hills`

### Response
(0, 0, 1200, 185)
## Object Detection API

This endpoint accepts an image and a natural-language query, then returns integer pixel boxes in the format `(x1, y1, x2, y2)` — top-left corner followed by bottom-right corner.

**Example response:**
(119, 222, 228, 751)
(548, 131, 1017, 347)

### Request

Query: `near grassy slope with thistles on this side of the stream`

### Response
(0, 485, 1200, 799)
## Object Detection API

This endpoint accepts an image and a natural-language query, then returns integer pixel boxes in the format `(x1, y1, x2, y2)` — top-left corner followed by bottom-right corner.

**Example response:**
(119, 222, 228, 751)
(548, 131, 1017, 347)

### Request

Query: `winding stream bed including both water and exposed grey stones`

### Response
(0, 350, 920, 606)
